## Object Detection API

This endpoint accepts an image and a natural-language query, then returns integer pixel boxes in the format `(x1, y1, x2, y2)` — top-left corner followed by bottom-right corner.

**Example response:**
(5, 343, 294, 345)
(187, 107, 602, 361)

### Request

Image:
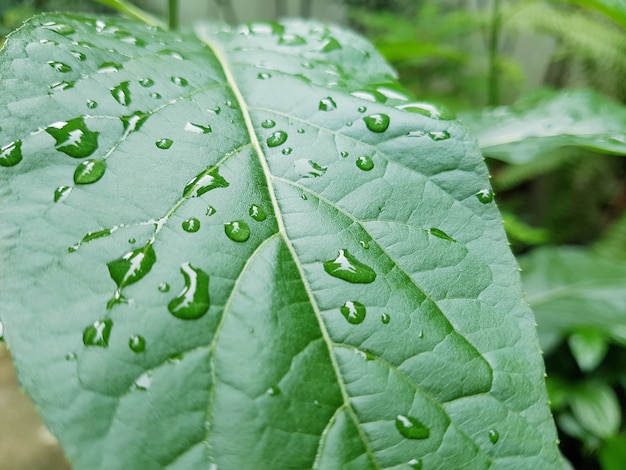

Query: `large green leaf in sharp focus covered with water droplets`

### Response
(0, 12, 563, 470)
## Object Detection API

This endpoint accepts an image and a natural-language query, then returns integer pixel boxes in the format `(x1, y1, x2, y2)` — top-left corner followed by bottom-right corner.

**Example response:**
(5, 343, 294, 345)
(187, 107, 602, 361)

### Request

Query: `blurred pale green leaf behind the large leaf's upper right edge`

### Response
(459, 90, 626, 165)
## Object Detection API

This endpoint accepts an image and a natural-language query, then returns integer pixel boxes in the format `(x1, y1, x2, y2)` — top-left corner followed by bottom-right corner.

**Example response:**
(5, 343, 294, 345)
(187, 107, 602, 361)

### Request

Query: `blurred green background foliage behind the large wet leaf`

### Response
(0, 0, 626, 470)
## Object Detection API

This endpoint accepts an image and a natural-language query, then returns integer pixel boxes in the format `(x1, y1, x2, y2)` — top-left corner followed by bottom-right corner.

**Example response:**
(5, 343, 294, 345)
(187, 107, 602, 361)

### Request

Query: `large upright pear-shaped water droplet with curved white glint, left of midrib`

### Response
(167, 263, 210, 320)
